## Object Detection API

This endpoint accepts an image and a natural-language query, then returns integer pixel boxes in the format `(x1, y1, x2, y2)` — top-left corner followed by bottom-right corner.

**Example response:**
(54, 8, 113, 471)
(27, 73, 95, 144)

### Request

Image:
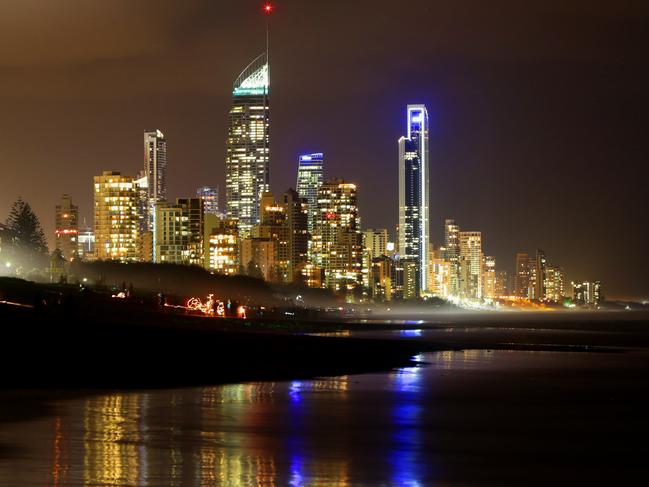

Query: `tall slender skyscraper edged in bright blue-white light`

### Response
(399, 105, 430, 295)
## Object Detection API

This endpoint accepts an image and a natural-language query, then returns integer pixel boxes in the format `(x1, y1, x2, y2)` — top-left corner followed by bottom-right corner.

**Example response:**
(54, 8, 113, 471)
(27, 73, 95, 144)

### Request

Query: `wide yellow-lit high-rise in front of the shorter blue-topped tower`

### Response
(313, 179, 363, 291)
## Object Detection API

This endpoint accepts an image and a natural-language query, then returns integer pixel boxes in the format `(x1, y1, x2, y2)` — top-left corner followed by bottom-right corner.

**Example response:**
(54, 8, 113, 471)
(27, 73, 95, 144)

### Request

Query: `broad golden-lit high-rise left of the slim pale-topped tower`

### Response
(94, 171, 140, 262)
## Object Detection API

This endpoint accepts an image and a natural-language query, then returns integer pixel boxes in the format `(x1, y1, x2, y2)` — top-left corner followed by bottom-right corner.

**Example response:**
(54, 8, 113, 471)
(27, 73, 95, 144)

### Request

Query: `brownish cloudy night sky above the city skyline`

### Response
(0, 0, 649, 298)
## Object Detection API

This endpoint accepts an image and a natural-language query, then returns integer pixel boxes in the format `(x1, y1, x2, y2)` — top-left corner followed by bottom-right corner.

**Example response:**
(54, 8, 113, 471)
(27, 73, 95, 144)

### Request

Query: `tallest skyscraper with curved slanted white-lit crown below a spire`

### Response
(225, 53, 270, 237)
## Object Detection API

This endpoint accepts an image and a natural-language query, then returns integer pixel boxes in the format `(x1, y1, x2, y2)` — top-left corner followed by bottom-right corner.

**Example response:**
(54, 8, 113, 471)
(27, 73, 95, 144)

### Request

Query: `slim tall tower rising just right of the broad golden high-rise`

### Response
(144, 129, 167, 232)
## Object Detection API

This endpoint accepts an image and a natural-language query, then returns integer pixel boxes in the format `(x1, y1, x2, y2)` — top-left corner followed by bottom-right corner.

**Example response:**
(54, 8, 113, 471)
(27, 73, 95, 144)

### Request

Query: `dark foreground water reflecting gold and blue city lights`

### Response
(0, 351, 649, 487)
